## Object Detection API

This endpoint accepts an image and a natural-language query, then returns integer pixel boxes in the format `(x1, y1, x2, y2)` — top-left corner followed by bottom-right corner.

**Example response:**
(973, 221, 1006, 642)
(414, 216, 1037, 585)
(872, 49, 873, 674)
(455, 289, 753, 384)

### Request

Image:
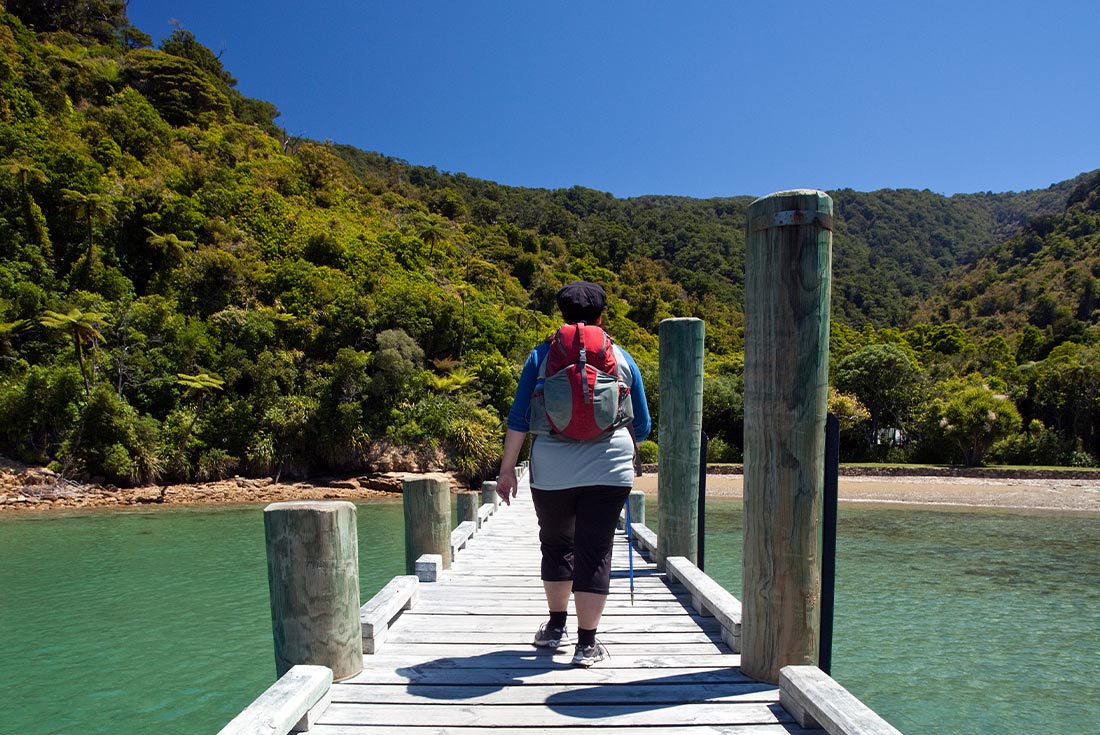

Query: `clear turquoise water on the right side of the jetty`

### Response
(704, 502, 1100, 735)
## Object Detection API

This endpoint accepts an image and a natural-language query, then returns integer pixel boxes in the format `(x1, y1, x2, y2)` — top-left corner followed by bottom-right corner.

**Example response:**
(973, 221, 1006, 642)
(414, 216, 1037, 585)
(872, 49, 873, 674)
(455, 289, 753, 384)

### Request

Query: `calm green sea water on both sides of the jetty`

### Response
(0, 500, 1100, 735)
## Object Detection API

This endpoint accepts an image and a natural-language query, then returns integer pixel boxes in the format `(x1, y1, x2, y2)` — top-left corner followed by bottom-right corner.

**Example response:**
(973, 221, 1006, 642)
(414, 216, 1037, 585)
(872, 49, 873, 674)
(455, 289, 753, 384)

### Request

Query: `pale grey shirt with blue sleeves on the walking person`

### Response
(507, 342, 652, 490)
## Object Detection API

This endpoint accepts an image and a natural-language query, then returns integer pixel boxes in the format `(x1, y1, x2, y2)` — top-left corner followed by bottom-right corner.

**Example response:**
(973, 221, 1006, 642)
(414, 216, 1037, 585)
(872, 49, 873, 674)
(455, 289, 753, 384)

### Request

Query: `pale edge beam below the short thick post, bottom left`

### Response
(218, 665, 332, 735)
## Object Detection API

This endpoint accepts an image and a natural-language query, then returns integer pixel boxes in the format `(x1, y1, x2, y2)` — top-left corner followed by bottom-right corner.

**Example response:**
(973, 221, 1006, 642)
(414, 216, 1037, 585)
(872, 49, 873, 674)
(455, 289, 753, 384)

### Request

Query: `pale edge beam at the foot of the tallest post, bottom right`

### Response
(779, 666, 901, 735)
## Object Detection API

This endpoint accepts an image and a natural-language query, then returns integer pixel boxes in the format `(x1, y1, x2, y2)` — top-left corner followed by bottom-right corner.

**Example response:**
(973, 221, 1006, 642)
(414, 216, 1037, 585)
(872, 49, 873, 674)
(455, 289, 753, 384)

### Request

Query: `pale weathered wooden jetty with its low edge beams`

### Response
(222, 468, 897, 735)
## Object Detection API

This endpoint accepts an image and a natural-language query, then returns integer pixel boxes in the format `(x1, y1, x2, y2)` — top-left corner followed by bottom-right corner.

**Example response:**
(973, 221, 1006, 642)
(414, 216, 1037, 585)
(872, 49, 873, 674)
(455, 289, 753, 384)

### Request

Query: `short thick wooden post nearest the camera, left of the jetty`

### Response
(264, 501, 363, 680)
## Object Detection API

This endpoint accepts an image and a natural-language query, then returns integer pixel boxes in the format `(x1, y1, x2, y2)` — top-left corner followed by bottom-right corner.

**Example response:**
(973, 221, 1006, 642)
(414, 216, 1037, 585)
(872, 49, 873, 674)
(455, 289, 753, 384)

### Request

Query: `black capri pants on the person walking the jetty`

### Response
(531, 485, 630, 594)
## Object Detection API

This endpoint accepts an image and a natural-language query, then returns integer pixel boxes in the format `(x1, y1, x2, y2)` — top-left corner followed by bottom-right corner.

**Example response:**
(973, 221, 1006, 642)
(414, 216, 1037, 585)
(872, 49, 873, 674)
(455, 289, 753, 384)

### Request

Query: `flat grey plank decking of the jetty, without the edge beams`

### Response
(309, 473, 822, 735)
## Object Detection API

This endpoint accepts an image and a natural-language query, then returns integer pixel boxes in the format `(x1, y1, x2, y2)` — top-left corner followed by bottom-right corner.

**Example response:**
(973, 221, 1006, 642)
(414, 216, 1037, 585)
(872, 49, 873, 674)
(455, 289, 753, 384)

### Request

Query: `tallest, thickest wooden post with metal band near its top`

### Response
(739, 190, 833, 682)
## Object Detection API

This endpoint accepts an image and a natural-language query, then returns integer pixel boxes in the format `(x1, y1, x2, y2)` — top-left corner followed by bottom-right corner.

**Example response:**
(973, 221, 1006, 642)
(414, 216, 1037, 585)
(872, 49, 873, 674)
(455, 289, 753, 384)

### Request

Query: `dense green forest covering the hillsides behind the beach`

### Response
(0, 0, 1100, 484)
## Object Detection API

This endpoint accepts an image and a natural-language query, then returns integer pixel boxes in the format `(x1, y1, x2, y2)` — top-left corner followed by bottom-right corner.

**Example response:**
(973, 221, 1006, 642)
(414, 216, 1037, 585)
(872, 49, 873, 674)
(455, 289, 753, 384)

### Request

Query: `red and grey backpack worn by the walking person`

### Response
(530, 321, 634, 441)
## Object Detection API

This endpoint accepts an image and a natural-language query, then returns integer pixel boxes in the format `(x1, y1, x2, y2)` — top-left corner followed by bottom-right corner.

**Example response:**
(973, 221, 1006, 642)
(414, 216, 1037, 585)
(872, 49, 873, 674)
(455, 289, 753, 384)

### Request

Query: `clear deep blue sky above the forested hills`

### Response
(129, 0, 1100, 197)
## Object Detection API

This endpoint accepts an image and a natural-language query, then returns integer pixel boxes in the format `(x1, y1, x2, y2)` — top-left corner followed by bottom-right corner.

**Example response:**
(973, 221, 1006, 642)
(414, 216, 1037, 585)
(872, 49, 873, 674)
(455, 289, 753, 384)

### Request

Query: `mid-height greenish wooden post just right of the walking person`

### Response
(657, 318, 704, 569)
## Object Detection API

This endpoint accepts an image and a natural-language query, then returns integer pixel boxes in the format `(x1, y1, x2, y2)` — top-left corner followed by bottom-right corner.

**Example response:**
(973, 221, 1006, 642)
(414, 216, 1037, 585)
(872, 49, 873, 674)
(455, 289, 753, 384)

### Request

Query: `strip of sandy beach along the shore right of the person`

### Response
(635, 474, 1100, 514)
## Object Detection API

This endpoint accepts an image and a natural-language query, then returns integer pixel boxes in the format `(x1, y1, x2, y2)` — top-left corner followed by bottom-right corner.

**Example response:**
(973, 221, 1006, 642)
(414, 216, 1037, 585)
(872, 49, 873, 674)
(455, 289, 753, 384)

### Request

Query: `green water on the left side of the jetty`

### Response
(0, 500, 405, 735)
